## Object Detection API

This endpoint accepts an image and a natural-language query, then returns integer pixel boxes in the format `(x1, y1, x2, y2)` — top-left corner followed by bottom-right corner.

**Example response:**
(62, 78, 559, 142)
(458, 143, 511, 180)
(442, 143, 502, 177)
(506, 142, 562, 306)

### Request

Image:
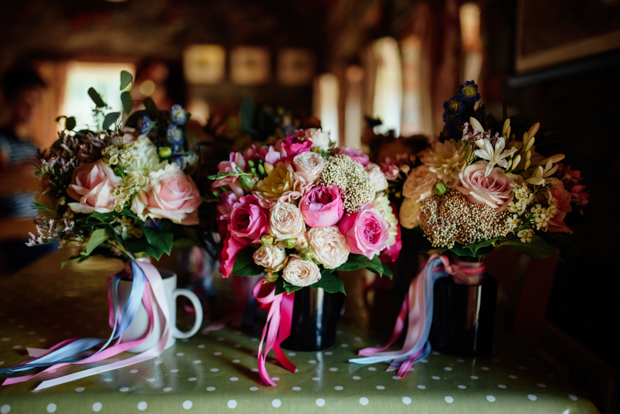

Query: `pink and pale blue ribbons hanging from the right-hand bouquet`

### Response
(349, 255, 484, 378)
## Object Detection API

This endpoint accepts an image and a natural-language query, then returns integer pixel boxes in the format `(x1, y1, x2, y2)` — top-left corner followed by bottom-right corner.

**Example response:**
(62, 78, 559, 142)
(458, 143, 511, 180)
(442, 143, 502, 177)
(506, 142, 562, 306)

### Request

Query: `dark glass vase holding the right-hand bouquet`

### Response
(430, 275, 497, 357)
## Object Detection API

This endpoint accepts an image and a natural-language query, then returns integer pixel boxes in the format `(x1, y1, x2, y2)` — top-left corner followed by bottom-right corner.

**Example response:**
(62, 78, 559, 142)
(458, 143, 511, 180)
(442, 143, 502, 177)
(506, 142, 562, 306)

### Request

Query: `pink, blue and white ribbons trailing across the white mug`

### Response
(0, 261, 170, 390)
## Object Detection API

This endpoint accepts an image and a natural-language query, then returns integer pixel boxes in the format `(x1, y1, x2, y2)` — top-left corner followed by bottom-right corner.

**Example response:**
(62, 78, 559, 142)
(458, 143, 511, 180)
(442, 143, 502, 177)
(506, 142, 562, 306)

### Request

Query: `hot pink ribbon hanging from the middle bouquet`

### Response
(252, 279, 297, 387)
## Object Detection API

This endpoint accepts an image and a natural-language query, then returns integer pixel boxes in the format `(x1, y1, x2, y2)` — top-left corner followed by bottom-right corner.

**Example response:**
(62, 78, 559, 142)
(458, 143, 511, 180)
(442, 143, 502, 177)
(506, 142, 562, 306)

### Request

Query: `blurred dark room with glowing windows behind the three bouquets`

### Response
(0, 0, 620, 410)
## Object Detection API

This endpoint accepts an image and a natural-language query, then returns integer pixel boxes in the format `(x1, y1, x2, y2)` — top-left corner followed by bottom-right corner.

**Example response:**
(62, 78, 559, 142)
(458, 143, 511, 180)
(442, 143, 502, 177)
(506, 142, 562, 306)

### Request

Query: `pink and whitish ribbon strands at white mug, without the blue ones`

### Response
(3, 262, 170, 390)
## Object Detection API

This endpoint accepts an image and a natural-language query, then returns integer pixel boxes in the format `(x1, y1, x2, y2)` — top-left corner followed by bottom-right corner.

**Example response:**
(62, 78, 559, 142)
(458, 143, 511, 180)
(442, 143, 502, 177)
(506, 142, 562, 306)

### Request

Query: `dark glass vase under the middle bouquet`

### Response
(282, 287, 344, 351)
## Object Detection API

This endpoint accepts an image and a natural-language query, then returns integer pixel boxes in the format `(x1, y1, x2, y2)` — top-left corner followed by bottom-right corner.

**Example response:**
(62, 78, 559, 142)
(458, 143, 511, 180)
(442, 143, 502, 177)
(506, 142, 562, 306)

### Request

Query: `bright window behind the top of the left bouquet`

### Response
(59, 62, 135, 129)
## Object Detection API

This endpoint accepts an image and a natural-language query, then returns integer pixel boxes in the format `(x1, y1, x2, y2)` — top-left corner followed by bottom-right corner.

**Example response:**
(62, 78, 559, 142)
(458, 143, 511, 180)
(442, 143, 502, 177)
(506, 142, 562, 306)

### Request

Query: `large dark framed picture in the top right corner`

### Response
(515, 0, 620, 73)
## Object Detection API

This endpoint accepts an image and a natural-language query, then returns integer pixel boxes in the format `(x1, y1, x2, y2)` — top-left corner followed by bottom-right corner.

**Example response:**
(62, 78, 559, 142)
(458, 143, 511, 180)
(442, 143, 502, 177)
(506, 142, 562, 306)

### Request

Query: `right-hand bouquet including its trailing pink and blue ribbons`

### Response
(352, 82, 588, 377)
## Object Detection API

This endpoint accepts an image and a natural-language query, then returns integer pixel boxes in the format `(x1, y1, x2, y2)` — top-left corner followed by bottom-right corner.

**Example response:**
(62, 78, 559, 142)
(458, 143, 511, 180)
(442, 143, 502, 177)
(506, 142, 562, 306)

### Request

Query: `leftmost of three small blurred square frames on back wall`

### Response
(183, 45, 226, 85)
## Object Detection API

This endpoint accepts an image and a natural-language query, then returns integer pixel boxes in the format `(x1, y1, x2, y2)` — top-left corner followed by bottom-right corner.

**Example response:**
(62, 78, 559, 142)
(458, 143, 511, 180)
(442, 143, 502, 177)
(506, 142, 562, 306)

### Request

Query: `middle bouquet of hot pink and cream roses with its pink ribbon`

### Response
(210, 129, 401, 385)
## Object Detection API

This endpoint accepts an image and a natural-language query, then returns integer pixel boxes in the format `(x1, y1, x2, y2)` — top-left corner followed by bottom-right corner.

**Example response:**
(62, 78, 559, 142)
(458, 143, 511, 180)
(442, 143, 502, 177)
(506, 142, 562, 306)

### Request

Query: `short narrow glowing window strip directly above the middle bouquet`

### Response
(314, 73, 339, 142)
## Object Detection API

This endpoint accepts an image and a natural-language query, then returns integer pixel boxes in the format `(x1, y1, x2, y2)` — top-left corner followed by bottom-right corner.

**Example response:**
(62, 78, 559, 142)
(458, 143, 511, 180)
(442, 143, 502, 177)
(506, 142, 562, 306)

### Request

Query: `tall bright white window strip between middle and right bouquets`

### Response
(373, 37, 403, 136)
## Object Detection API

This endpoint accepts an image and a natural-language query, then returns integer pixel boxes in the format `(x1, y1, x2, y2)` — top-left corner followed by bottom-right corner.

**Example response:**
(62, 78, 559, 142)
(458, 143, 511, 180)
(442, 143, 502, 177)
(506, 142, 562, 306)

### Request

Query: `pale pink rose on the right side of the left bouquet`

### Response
(131, 164, 202, 226)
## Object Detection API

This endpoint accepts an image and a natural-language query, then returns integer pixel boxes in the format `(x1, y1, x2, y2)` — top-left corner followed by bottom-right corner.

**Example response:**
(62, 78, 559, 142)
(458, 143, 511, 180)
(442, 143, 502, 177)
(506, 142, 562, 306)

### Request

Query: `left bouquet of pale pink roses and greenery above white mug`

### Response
(29, 72, 202, 260)
